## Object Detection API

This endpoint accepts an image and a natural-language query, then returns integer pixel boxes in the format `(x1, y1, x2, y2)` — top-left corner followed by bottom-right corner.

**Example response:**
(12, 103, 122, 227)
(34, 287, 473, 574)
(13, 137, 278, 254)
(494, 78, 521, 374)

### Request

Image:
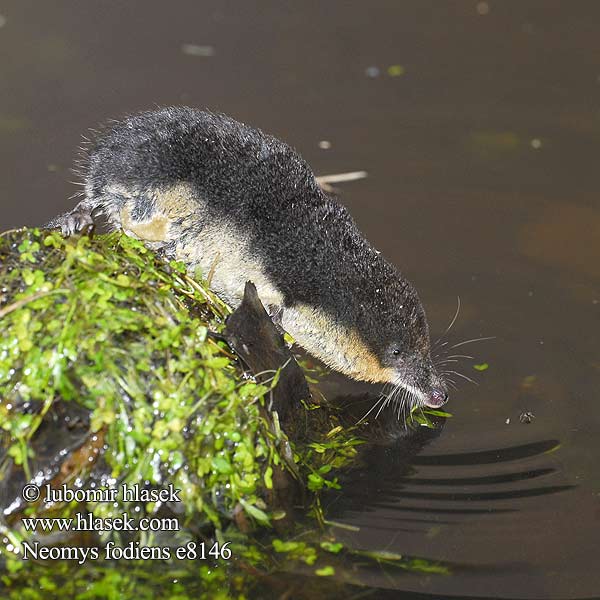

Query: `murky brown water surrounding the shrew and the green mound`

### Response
(0, 0, 600, 598)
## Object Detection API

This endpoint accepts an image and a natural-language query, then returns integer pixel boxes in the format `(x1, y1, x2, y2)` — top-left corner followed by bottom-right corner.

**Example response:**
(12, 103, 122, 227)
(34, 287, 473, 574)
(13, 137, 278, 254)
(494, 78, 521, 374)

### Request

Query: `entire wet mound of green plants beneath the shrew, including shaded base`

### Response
(0, 230, 450, 599)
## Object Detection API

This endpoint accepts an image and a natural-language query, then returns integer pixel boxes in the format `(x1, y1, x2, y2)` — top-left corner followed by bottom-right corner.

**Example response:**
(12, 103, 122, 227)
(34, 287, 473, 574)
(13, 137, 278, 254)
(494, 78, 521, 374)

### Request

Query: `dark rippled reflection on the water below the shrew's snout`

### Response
(324, 394, 575, 598)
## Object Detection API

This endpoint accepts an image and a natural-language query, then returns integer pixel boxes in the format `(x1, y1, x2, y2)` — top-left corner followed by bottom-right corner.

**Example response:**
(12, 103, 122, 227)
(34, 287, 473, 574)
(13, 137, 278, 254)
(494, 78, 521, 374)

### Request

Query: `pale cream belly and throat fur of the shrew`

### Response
(103, 184, 395, 382)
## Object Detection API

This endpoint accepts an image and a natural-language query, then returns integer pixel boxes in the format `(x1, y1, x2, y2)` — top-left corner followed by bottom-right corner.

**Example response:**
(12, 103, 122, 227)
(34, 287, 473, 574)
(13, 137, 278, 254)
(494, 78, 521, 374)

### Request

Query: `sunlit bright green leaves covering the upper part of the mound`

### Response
(0, 230, 310, 529)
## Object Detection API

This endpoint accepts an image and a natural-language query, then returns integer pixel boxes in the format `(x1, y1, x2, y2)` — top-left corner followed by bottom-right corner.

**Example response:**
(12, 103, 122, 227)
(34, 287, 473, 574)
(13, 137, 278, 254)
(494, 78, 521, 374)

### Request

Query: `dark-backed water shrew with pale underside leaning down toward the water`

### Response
(49, 108, 442, 406)
